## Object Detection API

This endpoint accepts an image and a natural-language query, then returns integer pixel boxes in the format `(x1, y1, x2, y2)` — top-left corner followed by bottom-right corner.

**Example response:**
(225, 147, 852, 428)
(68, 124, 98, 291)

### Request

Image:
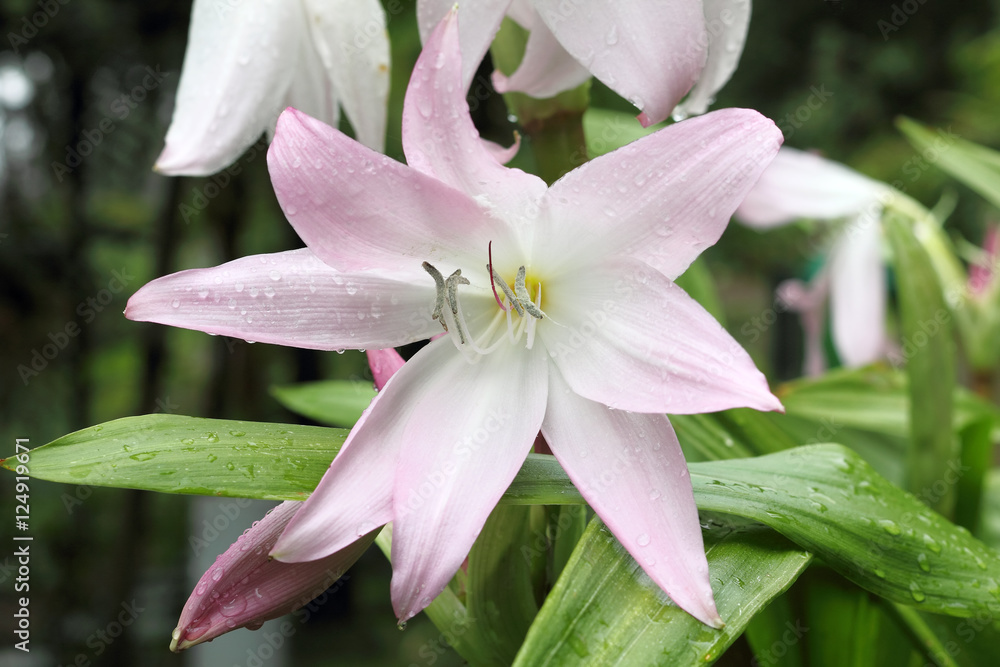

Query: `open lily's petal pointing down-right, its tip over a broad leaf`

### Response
(542, 368, 723, 628)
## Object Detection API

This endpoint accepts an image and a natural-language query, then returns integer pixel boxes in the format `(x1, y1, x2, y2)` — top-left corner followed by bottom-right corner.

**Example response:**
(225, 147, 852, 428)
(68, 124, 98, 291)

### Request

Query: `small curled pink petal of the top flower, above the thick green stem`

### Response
(493, 14, 590, 99)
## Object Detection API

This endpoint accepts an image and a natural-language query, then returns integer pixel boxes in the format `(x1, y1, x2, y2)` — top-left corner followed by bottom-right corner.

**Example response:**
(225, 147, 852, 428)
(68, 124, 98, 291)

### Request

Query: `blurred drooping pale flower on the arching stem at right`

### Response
(736, 147, 891, 367)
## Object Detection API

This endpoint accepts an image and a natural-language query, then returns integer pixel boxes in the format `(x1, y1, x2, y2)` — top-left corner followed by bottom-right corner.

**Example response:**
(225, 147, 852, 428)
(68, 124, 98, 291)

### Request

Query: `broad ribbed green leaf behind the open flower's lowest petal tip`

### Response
(514, 518, 810, 666)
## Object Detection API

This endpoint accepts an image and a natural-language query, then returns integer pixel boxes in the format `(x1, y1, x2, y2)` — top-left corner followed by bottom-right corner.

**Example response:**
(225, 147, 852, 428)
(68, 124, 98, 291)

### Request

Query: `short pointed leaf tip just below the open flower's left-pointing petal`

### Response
(271, 380, 375, 428)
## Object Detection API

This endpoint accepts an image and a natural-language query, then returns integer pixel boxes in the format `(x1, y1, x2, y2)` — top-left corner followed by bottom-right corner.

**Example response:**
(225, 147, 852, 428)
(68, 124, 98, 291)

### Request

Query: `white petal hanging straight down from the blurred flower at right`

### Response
(830, 214, 886, 366)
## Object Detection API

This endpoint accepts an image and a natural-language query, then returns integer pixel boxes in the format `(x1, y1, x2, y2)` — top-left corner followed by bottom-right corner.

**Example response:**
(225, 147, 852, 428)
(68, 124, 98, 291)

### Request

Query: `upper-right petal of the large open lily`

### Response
(536, 109, 781, 279)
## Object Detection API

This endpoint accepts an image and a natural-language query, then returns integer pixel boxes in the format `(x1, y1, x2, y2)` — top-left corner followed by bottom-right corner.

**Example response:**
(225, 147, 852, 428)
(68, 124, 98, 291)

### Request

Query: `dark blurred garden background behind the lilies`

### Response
(0, 0, 1000, 667)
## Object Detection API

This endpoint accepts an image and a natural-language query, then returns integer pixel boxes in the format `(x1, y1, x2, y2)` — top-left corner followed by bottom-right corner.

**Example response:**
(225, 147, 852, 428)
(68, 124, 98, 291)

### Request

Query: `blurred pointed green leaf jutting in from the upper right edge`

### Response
(896, 117, 1000, 207)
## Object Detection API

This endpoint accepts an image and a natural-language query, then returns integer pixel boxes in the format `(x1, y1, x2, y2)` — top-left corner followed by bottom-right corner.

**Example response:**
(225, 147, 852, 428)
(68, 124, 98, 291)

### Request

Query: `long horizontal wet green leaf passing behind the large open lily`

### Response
(3, 415, 1000, 616)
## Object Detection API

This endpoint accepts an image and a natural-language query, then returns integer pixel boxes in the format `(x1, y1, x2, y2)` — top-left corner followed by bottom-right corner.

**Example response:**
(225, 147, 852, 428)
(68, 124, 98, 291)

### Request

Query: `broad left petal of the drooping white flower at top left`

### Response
(156, 0, 306, 176)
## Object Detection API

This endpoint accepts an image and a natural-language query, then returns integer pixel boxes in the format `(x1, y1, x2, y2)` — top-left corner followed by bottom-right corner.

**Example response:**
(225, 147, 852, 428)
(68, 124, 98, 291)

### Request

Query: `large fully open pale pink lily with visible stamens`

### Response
(126, 12, 781, 627)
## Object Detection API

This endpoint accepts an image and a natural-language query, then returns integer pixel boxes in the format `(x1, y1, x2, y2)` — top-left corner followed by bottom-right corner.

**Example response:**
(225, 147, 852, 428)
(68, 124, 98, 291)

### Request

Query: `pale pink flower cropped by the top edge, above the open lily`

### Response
(417, 0, 750, 127)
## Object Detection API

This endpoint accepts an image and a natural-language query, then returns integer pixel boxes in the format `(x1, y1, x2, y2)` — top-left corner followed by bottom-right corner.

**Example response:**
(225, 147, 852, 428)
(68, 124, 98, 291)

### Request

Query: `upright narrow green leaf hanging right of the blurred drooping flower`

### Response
(883, 215, 957, 516)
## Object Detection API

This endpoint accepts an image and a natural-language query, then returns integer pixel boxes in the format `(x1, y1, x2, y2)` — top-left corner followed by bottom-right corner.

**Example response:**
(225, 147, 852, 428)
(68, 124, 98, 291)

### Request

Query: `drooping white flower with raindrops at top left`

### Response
(155, 0, 389, 176)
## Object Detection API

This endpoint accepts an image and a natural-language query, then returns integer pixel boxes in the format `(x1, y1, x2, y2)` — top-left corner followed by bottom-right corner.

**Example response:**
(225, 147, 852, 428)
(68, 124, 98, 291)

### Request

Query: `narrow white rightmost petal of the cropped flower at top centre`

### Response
(674, 0, 750, 118)
